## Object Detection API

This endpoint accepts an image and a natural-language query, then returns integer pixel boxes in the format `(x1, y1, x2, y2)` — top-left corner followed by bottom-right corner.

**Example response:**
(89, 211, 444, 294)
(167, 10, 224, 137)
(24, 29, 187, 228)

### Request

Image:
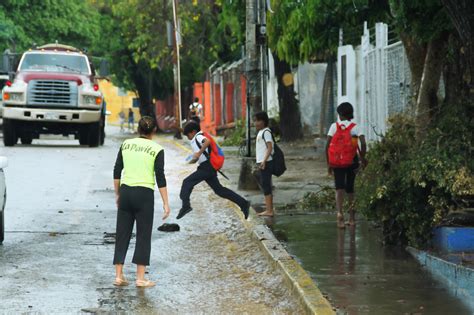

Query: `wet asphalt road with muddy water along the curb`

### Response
(0, 128, 301, 314)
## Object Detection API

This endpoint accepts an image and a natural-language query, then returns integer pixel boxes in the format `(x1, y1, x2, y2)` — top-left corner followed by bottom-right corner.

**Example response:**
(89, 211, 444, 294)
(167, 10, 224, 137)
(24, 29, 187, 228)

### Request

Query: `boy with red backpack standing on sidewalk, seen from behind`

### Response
(326, 102, 367, 228)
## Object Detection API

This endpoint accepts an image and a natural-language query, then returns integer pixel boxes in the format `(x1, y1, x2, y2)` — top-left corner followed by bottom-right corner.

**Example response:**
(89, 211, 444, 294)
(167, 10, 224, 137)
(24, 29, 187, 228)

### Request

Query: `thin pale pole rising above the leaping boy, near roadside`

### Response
(171, 0, 182, 137)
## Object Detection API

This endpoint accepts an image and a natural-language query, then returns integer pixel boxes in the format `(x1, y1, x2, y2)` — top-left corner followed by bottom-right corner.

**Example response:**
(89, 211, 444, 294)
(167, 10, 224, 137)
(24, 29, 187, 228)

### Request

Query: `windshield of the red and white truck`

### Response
(20, 53, 89, 74)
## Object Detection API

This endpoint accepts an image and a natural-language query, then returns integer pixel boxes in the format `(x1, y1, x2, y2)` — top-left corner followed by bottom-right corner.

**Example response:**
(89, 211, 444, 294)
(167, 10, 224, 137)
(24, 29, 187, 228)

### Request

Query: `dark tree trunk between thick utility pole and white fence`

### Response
(273, 53, 303, 141)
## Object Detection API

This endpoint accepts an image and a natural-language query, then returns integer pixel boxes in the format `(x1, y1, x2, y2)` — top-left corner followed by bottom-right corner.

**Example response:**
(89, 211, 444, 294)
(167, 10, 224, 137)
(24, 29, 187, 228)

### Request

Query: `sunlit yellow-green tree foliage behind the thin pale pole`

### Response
(91, 0, 243, 119)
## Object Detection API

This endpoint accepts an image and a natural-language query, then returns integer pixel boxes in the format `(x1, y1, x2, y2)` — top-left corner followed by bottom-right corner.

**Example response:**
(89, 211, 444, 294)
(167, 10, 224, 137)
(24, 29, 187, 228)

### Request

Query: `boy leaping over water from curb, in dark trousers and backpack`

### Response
(177, 121, 250, 219)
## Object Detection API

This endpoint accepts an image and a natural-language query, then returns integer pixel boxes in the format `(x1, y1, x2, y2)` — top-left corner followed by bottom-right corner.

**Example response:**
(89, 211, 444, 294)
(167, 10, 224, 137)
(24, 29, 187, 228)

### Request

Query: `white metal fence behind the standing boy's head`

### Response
(338, 23, 412, 141)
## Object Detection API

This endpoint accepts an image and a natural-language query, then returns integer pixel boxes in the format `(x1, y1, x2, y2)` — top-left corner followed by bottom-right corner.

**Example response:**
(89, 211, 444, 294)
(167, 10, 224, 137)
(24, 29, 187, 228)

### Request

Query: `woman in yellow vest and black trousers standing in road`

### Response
(114, 116, 170, 287)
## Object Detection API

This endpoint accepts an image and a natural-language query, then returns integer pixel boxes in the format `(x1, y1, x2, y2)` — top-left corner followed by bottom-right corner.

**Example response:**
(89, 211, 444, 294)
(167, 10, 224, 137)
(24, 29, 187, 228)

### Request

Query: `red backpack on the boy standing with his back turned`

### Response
(328, 123, 358, 168)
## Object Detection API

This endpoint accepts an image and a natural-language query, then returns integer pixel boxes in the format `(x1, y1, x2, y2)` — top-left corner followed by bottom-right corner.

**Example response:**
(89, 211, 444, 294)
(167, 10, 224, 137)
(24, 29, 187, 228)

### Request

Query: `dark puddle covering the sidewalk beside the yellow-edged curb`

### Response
(267, 214, 474, 315)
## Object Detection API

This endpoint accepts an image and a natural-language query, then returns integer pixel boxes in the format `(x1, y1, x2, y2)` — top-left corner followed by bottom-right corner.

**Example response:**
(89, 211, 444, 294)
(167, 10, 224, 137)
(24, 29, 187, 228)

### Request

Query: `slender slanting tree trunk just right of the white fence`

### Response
(416, 34, 447, 140)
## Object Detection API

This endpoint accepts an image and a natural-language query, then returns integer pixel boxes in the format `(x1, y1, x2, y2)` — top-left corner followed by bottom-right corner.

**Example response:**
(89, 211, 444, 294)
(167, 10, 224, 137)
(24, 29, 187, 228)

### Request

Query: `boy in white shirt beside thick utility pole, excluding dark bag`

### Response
(254, 112, 275, 217)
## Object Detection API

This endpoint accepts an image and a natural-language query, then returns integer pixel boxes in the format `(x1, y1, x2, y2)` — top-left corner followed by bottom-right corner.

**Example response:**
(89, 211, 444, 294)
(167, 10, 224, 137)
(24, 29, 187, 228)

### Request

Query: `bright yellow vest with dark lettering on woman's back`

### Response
(120, 138, 163, 190)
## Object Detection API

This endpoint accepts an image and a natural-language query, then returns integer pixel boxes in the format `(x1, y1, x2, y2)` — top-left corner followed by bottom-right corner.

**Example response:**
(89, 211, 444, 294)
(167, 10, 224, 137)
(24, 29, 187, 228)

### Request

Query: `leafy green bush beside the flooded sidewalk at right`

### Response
(356, 105, 474, 247)
